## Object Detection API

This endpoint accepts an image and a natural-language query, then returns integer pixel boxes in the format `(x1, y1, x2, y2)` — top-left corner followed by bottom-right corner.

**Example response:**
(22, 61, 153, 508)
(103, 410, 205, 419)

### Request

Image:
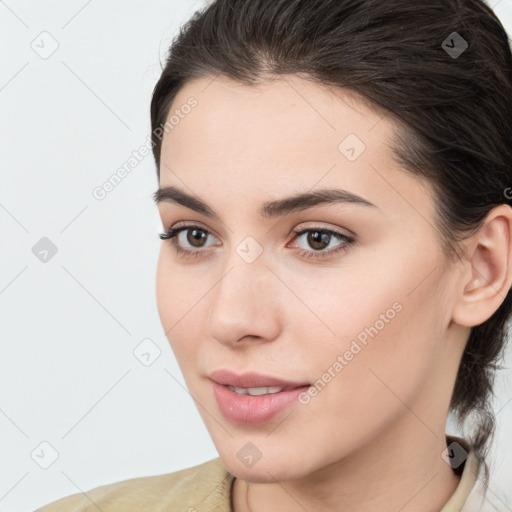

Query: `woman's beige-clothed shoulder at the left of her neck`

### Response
(36, 457, 234, 512)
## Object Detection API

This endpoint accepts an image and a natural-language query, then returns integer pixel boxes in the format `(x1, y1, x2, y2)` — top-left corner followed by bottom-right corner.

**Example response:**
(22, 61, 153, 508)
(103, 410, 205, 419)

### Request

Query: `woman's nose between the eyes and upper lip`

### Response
(208, 254, 283, 348)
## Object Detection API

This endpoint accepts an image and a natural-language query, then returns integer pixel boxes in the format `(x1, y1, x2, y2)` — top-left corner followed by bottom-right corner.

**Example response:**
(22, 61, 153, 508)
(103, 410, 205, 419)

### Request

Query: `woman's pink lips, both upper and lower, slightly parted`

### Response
(210, 370, 310, 425)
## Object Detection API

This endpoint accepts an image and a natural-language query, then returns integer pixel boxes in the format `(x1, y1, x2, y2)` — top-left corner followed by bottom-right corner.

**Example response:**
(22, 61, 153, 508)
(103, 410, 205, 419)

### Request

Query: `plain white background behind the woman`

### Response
(0, 0, 512, 512)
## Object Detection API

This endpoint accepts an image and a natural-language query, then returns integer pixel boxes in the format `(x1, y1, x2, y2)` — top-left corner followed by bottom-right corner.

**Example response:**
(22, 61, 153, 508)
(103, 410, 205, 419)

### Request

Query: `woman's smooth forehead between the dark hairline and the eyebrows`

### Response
(160, 75, 431, 225)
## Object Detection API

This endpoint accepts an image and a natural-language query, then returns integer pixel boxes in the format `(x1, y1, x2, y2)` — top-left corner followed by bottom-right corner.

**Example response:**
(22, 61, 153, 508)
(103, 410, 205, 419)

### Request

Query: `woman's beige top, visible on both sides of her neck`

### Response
(36, 436, 495, 512)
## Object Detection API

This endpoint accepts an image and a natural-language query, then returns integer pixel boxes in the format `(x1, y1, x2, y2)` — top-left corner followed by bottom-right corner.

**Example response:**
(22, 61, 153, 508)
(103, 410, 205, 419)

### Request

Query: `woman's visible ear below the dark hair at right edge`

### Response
(453, 204, 512, 327)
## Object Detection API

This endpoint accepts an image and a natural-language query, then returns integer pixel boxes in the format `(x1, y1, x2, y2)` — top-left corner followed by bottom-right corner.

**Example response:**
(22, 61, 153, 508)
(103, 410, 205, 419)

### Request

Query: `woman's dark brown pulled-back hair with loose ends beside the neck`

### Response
(151, 0, 512, 484)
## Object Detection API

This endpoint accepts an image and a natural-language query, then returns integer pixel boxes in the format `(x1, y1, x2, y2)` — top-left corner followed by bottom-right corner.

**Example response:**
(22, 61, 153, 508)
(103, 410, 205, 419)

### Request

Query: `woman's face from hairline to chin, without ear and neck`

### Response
(157, 76, 467, 482)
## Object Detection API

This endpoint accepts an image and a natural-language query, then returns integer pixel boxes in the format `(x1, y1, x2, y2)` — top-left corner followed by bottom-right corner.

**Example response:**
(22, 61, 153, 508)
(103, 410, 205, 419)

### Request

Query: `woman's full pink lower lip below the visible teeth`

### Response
(212, 381, 310, 425)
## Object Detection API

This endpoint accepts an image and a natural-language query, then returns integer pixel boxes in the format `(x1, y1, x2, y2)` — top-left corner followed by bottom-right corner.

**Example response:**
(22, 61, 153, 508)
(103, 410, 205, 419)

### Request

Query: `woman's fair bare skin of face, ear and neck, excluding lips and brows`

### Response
(156, 75, 512, 512)
